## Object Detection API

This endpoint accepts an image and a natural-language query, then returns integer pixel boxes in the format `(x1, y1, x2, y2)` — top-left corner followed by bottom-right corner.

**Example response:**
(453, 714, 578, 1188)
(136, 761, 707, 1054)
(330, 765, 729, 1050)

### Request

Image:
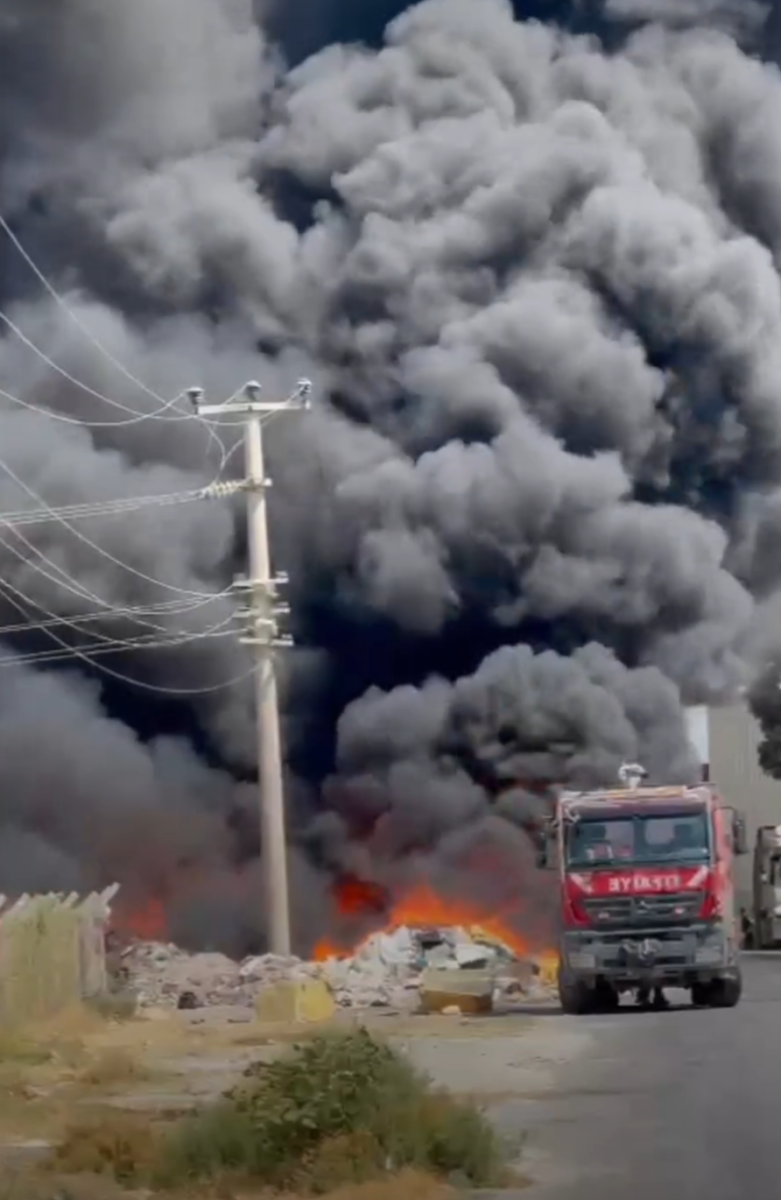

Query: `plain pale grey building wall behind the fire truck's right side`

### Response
(708, 704, 781, 906)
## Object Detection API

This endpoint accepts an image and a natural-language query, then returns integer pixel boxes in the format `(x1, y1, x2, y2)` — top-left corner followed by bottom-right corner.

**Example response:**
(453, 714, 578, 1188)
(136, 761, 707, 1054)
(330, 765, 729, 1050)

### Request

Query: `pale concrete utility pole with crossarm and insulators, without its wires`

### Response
(188, 379, 312, 955)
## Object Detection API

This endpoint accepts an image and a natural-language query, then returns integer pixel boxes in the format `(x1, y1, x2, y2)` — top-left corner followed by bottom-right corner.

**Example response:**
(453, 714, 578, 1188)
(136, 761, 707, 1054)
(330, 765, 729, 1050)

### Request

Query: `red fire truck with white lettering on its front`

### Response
(539, 764, 746, 1013)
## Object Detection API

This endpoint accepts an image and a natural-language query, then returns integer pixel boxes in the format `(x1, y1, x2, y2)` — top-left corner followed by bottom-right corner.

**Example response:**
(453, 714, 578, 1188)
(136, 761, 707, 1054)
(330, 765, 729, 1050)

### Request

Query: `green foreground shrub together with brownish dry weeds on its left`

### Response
(27, 1032, 506, 1200)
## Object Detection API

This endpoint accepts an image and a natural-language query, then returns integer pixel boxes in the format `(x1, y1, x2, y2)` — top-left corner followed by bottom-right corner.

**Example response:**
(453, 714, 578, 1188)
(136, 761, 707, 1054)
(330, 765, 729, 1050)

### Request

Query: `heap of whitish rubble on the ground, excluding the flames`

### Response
(118, 926, 551, 1013)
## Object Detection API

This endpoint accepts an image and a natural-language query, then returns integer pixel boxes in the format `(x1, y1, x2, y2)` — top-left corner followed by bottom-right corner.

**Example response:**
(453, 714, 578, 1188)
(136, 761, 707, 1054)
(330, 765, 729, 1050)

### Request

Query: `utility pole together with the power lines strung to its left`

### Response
(0, 222, 311, 796)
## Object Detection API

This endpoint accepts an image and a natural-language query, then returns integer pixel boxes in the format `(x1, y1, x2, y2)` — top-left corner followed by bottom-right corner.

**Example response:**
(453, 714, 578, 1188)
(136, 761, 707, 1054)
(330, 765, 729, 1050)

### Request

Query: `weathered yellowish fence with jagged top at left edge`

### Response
(0, 884, 119, 1025)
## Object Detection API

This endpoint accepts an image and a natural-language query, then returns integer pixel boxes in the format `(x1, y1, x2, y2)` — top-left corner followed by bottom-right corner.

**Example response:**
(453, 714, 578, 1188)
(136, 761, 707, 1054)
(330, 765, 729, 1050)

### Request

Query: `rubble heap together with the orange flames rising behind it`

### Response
(109, 882, 557, 1014)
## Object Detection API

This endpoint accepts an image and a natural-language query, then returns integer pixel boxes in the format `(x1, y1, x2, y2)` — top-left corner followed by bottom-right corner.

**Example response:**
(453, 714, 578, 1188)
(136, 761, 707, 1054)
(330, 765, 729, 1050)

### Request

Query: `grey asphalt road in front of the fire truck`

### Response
(495, 955, 781, 1200)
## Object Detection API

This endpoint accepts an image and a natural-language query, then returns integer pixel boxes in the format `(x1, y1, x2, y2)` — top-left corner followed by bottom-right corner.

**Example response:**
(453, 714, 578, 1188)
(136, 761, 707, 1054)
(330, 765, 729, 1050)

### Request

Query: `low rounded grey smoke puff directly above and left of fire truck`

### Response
(316, 643, 692, 859)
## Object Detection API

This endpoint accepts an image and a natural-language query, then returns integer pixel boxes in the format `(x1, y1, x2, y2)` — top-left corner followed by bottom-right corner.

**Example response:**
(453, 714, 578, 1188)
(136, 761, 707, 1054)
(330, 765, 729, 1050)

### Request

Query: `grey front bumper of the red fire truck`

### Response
(561, 926, 737, 990)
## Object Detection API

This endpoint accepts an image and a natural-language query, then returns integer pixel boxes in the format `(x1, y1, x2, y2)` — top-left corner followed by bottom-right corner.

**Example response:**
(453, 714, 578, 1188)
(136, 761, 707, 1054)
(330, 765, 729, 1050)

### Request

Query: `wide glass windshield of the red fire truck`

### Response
(566, 811, 710, 868)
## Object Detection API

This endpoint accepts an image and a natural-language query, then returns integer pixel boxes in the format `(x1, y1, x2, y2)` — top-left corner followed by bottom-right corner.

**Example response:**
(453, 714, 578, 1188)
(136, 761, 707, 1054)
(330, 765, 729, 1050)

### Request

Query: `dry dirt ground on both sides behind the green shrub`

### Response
(0, 1010, 583, 1200)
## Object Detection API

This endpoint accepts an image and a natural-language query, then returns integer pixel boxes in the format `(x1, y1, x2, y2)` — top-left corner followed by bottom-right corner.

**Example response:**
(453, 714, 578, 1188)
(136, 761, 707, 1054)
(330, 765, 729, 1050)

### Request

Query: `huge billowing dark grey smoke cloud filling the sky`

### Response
(0, 0, 781, 947)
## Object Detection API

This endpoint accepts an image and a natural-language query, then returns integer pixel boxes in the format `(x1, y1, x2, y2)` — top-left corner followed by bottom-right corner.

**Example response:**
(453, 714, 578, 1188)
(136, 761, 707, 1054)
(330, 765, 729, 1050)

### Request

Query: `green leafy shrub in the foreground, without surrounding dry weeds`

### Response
(158, 1031, 504, 1193)
